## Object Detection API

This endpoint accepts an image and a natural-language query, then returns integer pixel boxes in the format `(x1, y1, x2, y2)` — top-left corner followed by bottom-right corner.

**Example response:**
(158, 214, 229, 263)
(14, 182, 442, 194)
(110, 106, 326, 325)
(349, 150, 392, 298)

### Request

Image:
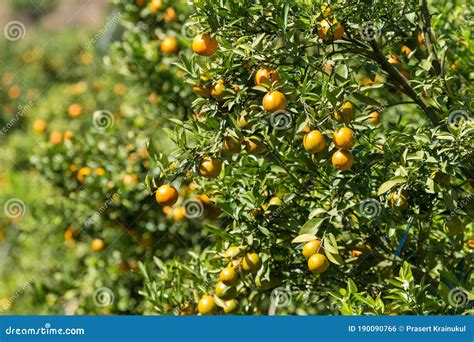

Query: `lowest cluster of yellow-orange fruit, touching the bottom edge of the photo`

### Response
(198, 247, 262, 315)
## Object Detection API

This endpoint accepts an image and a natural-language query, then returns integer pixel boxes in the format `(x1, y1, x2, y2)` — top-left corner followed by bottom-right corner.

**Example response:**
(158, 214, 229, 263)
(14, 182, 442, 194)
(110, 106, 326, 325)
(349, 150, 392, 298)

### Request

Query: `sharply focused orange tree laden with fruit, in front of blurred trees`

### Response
(139, 0, 473, 314)
